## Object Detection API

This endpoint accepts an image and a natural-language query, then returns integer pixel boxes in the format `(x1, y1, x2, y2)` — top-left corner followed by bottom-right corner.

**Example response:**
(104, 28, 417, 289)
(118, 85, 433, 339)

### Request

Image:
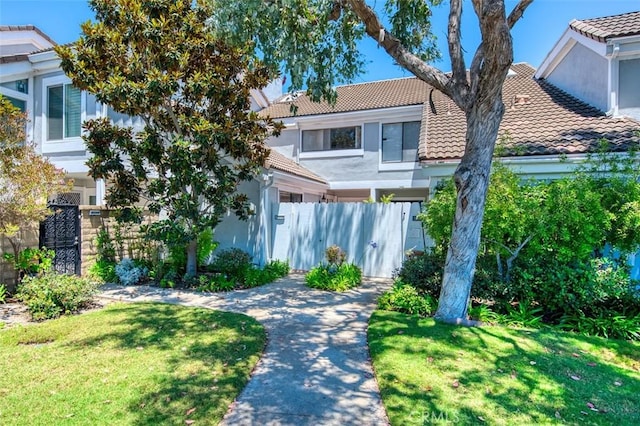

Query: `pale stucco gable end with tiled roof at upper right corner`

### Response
(536, 11, 640, 120)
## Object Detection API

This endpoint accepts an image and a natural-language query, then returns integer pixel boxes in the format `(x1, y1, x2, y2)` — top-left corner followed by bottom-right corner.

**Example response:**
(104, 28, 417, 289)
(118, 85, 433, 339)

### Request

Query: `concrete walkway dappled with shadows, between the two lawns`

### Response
(101, 275, 391, 426)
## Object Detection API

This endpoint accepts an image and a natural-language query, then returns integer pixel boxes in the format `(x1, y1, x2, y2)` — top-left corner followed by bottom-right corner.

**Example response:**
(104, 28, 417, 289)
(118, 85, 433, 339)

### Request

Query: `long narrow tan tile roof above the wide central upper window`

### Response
(260, 77, 429, 118)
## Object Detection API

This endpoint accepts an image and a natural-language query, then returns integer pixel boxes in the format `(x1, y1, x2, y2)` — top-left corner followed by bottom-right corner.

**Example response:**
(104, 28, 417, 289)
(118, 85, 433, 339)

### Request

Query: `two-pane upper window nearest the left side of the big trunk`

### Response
(382, 121, 420, 163)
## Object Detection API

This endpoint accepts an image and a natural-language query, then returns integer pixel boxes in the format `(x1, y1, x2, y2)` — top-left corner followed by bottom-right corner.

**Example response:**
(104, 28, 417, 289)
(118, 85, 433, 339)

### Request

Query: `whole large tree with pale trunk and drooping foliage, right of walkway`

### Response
(211, 0, 533, 323)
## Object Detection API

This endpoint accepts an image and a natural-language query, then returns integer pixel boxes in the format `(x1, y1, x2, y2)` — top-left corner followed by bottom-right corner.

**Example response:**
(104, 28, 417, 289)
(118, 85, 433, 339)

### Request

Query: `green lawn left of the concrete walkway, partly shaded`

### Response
(0, 303, 266, 425)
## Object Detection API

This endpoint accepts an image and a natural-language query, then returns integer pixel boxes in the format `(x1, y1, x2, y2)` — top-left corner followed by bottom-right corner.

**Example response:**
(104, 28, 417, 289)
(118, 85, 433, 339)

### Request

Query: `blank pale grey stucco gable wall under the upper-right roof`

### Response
(547, 44, 609, 111)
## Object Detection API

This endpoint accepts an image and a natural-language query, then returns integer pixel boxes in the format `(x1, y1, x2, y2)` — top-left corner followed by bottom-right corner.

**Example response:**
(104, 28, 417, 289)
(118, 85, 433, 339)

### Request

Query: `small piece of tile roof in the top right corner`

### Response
(569, 11, 640, 43)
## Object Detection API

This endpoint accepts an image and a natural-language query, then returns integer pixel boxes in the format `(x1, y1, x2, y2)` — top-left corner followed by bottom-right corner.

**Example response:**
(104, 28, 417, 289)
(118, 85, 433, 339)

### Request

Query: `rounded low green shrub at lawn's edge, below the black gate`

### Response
(16, 271, 97, 320)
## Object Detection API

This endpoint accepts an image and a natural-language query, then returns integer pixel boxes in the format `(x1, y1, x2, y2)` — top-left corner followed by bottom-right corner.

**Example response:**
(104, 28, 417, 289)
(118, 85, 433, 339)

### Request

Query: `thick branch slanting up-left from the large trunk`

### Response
(346, 0, 455, 97)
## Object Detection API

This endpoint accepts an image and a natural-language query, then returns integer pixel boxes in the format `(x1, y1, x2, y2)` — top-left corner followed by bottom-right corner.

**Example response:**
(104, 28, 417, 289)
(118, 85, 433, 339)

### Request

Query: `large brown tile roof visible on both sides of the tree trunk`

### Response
(419, 64, 640, 162)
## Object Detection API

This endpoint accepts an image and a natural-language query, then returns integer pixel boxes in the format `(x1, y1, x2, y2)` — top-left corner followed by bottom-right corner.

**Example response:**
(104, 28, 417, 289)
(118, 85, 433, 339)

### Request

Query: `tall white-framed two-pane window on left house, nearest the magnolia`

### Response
(45, 79, 82, 141)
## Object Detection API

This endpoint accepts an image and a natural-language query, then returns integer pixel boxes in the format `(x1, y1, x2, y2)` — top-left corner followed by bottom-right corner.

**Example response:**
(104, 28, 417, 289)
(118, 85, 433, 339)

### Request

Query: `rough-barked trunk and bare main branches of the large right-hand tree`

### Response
(344, 0, 533, 325)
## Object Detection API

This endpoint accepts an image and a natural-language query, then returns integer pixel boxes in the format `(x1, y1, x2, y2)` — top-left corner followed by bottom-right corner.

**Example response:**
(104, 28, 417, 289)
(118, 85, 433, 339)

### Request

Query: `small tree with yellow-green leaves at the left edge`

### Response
(0, 95, 71, 279)
